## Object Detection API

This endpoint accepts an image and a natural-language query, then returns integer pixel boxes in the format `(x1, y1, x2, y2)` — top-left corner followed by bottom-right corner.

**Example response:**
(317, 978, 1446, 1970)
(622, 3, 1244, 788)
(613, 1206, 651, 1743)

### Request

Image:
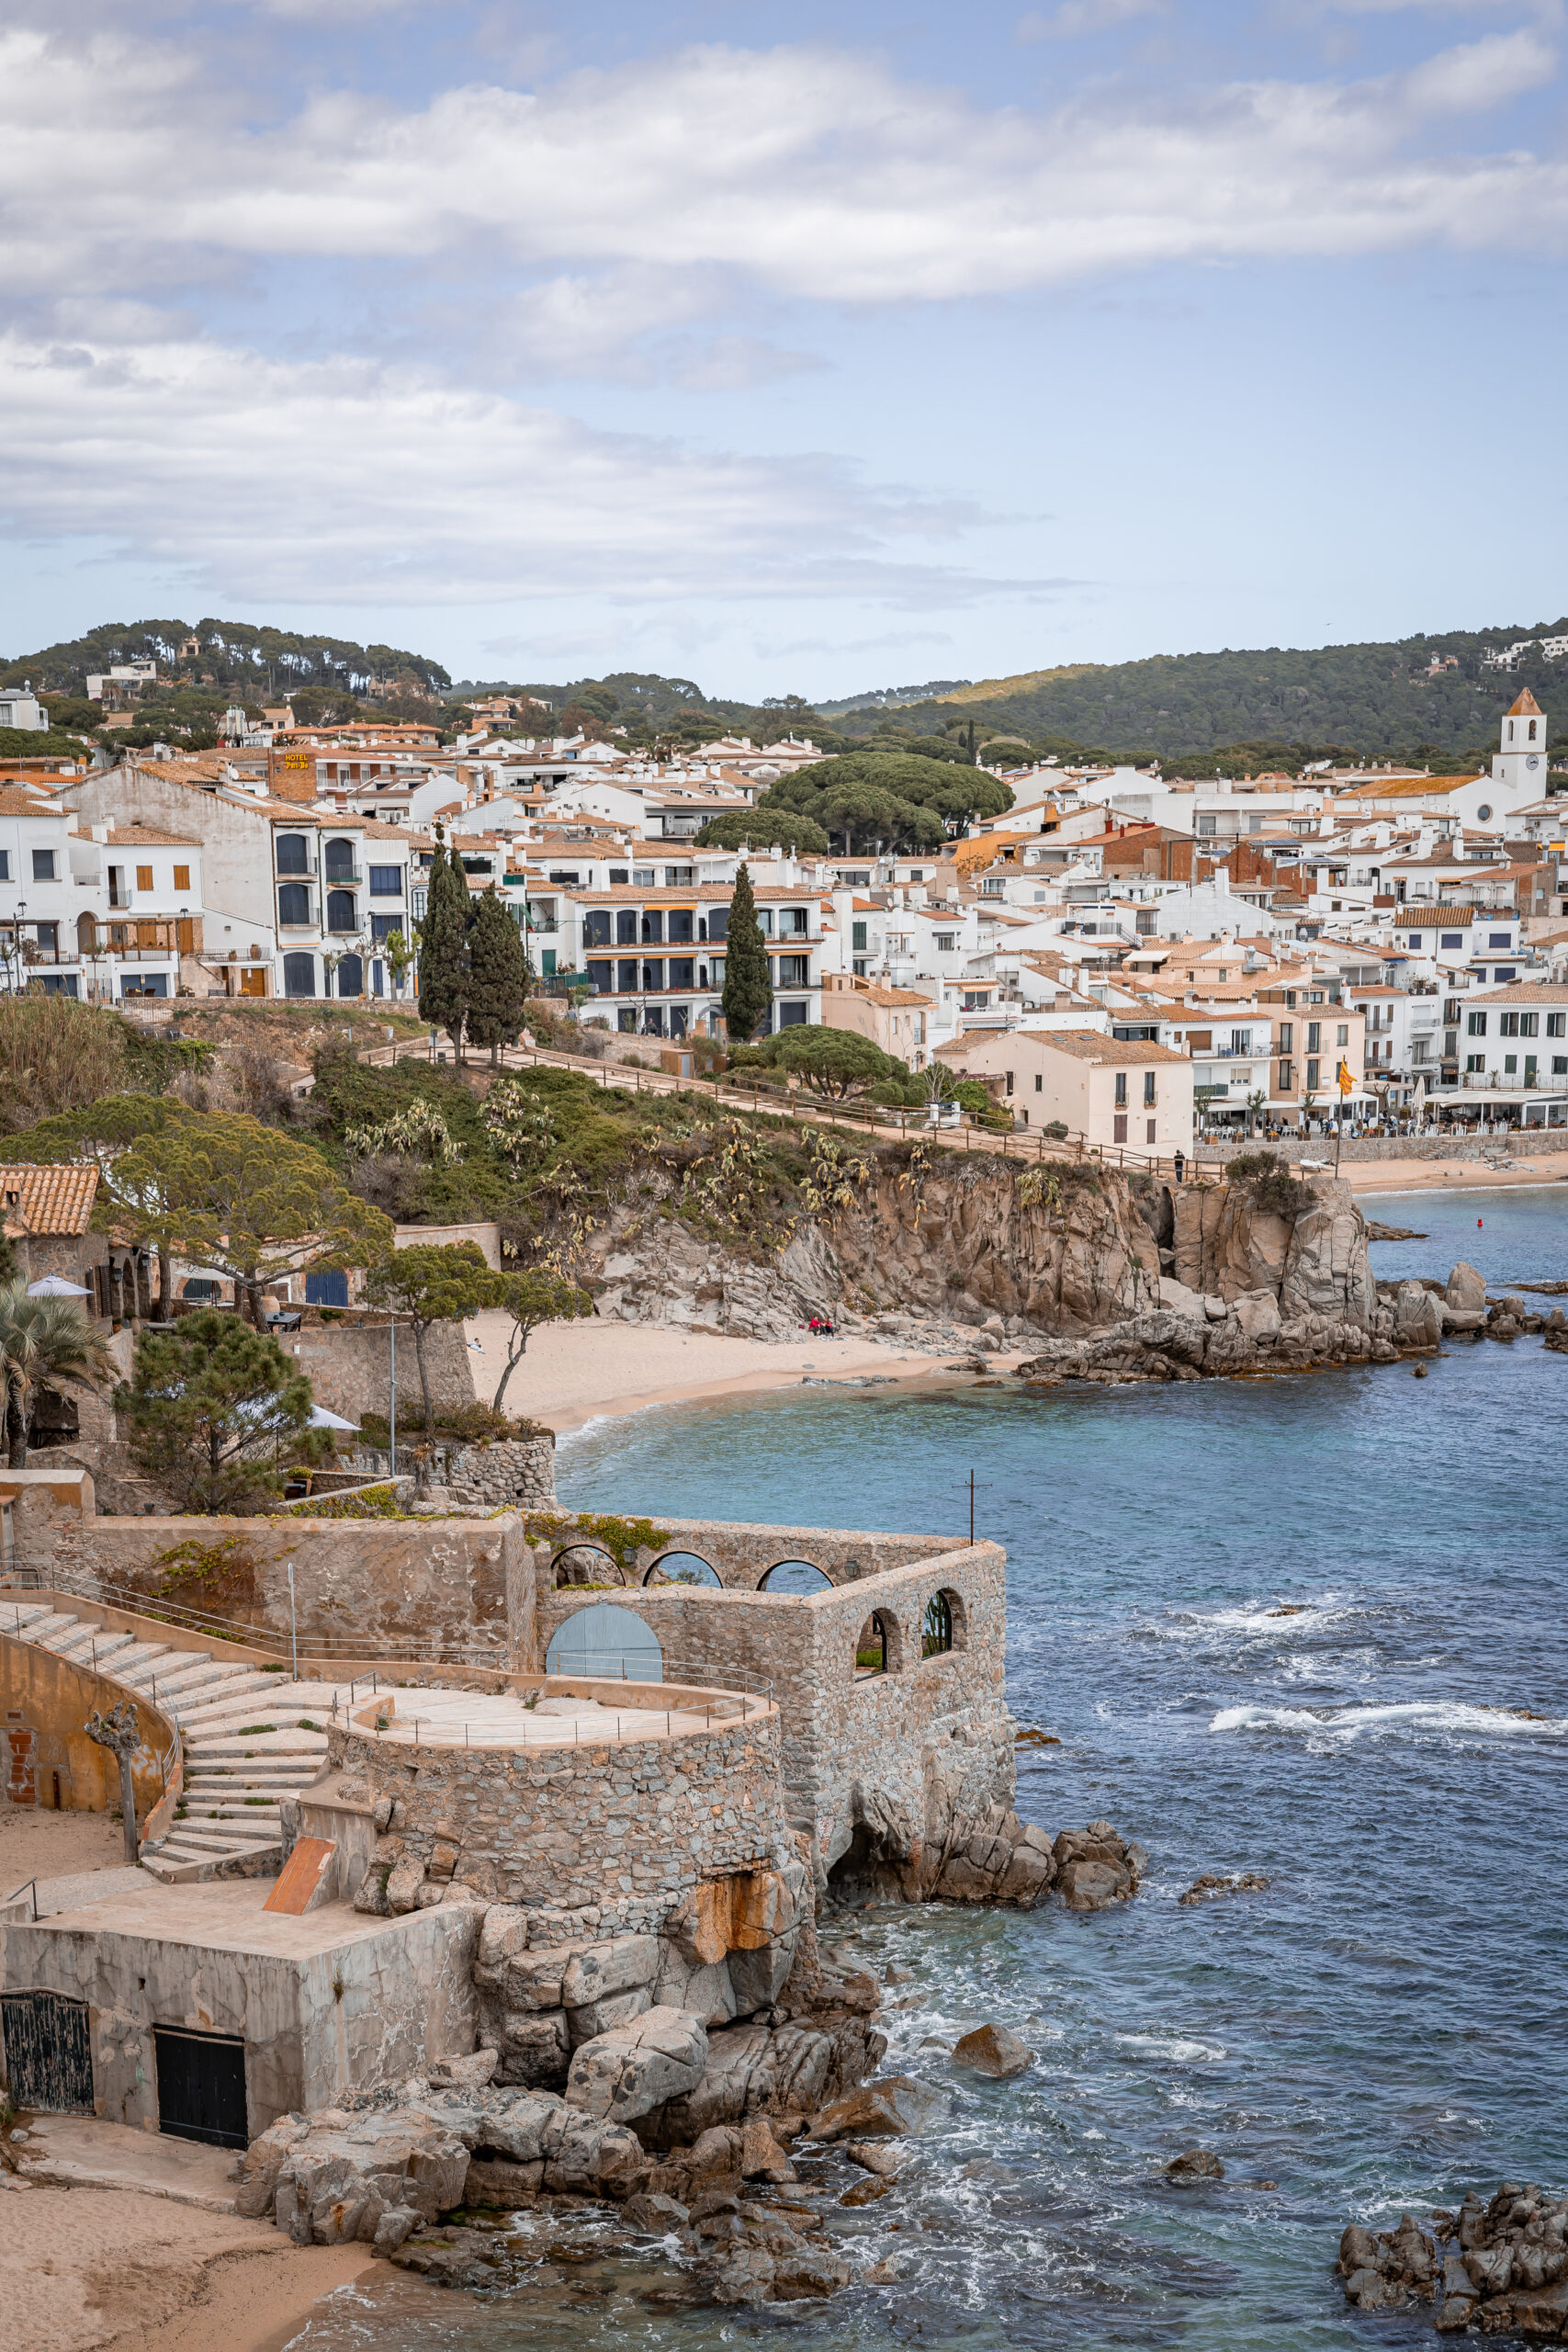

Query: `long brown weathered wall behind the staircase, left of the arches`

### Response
(33, 1512, 534, 1665)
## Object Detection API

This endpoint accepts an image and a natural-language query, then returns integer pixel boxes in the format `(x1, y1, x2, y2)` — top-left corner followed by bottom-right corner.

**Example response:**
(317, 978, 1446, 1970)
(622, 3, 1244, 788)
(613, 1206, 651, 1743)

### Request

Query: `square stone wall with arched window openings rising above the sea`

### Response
(538, 1521, 1013, 1891)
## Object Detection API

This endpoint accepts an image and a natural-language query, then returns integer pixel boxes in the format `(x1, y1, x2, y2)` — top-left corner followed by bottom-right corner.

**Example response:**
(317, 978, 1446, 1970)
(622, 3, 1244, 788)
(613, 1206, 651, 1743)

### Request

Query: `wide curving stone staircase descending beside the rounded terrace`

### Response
(0, 1595, 336, 1879)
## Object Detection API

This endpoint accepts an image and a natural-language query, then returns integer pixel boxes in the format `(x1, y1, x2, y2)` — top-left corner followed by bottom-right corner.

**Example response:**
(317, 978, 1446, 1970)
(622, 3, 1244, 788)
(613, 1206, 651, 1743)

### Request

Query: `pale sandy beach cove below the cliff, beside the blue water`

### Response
(468, 1315, 964, 1432)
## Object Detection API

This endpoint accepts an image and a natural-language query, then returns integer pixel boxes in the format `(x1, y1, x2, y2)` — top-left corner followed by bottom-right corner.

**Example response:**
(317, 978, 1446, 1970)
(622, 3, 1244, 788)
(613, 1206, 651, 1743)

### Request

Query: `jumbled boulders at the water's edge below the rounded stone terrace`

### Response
(235, 1814, 1147, 2305)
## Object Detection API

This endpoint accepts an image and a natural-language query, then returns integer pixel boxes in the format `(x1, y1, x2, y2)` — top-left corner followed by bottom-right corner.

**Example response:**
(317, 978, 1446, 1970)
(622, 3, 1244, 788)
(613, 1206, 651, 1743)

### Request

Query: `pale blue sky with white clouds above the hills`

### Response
(0, 0, 1568, 698)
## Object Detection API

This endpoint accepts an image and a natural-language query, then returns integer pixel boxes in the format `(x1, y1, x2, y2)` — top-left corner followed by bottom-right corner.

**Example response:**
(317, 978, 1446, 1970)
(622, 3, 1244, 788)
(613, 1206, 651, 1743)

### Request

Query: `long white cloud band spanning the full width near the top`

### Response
(0, 30, 1568, 303)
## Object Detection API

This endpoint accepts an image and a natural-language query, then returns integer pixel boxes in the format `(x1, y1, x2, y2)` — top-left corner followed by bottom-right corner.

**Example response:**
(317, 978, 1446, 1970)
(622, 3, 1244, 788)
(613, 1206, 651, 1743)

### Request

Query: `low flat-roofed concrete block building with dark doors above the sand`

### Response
(0, 1882, 478, 2133)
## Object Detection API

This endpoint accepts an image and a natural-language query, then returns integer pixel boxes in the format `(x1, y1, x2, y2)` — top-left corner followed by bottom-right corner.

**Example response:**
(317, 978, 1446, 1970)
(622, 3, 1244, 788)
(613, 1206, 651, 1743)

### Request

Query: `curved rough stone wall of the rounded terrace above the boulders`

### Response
(329, 1708, 787, 1933)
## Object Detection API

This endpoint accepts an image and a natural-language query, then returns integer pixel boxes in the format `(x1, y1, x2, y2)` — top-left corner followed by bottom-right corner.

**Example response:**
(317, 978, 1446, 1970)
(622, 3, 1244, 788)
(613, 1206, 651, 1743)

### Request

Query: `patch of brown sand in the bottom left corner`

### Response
(0, 2183, 373, 2352)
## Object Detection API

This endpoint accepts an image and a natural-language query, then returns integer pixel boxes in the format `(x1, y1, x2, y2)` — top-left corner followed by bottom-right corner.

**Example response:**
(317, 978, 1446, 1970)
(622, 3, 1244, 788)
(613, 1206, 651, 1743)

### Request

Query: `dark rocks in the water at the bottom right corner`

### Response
(1337, 2180, 1568, 2338)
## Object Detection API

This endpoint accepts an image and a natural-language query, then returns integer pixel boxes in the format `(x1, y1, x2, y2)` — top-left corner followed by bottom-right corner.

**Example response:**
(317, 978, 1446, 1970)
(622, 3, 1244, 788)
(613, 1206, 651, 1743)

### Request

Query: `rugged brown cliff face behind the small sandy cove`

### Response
(583, 1148, 1378, 1348)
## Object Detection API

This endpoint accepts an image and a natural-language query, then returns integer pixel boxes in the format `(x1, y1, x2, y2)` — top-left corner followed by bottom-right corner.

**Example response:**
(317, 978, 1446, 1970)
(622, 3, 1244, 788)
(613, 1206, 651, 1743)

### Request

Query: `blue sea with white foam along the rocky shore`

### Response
(296, 1183, 1568, 2352)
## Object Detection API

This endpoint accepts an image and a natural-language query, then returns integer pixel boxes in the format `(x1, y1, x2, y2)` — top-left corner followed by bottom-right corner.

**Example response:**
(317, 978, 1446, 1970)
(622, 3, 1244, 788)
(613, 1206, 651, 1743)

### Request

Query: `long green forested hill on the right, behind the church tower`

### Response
(837, 618, 1568, 757)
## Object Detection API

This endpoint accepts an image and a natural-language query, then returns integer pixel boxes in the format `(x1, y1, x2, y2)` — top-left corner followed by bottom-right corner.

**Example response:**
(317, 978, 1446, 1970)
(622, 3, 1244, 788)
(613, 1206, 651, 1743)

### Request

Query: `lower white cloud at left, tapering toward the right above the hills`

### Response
(0, 336, 1046, 609)
